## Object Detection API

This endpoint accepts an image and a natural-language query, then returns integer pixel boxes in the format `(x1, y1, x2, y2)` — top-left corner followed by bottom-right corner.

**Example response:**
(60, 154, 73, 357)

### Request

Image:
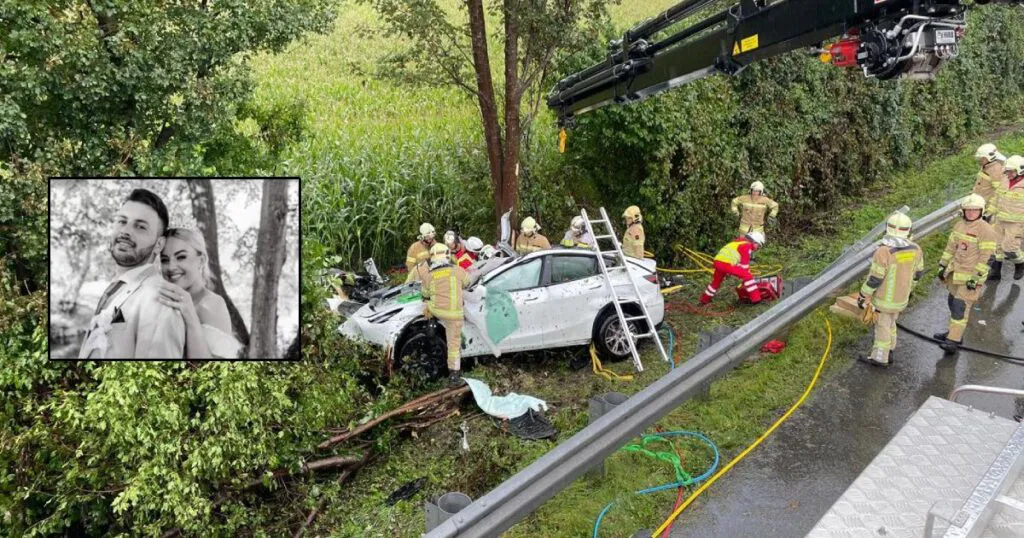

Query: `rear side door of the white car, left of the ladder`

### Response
(544, 251, 610, 347)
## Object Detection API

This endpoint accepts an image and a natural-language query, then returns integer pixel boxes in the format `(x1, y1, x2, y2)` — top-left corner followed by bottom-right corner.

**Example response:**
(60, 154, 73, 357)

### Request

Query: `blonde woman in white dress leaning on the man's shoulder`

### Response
(158, 227, 242, 359)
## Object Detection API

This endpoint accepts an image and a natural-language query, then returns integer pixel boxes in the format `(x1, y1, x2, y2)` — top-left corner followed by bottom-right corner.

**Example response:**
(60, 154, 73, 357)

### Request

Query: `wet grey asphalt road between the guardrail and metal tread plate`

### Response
(671, 271, 1024, 538)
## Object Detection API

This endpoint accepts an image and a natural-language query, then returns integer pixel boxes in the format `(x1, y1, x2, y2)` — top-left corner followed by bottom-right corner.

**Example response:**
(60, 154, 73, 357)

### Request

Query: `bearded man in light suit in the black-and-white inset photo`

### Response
(79, 189, 185, 359)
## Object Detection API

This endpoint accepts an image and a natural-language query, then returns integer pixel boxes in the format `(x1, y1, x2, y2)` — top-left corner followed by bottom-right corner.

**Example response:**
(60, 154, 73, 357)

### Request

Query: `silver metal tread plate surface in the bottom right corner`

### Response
(807, 397, 1018, 538)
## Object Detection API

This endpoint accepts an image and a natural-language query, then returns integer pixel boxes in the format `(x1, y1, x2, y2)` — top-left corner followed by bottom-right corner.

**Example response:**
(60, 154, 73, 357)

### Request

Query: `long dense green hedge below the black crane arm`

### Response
(563, 6, 1024, 253)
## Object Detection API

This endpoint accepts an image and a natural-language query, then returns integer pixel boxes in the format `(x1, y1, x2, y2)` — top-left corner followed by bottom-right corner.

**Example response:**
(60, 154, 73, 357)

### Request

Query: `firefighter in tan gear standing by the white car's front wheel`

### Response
(420, 244, 470, 387)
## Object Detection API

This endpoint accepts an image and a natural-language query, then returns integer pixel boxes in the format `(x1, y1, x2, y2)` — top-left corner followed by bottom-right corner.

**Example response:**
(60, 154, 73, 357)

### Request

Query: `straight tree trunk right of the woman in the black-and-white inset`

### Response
(249, 179, 289, 359)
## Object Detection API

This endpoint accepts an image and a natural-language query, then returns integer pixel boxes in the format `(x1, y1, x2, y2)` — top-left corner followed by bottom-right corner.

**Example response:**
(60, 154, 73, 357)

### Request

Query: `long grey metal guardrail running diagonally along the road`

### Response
(427, 196, 958, 538)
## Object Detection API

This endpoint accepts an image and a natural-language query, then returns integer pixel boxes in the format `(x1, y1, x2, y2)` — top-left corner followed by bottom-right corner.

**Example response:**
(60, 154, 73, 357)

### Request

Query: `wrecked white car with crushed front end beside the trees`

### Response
(338, 249, 665, 372)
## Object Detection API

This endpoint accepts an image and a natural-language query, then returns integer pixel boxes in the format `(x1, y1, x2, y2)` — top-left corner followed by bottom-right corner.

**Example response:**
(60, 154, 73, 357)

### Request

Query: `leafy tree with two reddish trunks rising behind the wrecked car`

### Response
(364, 0, 610, 228)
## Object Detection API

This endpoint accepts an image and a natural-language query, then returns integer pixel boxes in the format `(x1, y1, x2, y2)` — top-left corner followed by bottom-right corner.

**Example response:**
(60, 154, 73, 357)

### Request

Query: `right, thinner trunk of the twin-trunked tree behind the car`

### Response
(496, 0, 522, 227)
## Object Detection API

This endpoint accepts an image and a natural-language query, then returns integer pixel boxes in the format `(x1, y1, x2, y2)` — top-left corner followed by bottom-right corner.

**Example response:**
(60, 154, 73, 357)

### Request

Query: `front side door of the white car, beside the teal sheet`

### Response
(483, 256, 548, 353)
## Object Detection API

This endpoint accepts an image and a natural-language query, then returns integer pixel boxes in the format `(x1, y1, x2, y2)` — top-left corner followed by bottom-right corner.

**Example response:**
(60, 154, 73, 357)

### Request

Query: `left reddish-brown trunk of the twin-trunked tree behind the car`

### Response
(466, 0, 505, 233)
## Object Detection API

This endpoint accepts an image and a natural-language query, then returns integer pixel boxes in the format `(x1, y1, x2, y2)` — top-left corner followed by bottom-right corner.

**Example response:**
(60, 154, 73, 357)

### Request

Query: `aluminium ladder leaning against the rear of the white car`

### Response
(580, 207, 671, 372)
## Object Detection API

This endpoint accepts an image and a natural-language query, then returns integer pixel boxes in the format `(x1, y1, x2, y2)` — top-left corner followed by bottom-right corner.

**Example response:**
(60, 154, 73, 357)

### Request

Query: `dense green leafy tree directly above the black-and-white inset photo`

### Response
(0, 0, 339, 175)
